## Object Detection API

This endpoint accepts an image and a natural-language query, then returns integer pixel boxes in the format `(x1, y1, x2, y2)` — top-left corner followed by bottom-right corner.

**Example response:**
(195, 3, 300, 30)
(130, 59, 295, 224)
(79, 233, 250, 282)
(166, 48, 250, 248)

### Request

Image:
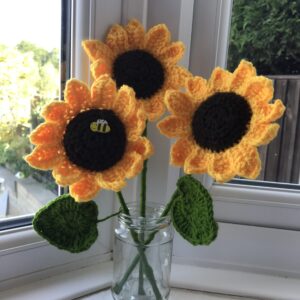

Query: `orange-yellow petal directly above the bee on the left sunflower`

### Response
(91, 75, 117, 109)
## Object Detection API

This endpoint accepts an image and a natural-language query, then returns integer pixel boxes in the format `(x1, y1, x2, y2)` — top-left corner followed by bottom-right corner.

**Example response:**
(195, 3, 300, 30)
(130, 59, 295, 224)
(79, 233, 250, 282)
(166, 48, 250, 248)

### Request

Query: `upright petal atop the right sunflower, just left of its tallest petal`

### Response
(208, 67, 232, 92)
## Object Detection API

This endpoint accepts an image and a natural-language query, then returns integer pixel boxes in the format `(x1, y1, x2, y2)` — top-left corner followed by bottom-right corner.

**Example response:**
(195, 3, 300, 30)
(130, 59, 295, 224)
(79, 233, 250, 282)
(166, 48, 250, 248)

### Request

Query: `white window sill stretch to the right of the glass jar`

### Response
(171, 264, 300, 300)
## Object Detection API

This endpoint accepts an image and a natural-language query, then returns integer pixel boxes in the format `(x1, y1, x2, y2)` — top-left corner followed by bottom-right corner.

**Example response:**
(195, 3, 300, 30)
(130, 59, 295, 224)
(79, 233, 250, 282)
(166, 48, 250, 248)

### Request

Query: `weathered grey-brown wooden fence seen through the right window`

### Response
(258, 76, 300, 184)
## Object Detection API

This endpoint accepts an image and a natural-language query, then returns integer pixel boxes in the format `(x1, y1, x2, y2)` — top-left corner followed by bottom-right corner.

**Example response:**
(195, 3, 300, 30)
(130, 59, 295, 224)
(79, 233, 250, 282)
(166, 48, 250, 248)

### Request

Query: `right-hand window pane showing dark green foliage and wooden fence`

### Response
(228, 0, 300, 188)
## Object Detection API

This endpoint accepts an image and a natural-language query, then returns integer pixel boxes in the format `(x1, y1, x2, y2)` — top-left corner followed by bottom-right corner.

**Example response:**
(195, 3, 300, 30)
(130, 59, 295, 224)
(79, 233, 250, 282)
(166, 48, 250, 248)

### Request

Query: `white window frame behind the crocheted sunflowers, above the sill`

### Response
(0, 0, 300, 299)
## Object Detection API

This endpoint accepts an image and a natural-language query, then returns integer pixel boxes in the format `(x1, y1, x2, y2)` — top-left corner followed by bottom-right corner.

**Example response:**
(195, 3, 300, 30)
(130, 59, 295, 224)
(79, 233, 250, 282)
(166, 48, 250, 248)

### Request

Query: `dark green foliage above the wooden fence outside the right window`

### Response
(228, 0, 300, 75)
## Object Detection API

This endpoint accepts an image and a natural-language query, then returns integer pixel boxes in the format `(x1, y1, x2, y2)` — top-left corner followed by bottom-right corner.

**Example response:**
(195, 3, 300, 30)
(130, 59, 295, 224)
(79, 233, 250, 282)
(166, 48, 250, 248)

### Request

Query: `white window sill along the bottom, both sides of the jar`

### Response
(0, 261, 300, 300)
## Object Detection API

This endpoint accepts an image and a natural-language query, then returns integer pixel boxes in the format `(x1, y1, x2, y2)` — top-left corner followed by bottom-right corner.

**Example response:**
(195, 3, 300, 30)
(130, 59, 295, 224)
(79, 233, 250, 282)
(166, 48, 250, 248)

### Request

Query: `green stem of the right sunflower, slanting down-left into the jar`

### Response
(113, 191, 178, 294)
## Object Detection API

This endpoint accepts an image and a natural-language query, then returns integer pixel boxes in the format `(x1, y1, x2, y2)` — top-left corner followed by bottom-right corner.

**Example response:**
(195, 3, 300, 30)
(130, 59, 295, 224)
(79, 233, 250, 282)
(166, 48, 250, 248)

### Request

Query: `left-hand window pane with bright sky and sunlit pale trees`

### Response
(0, 0, 61, 221)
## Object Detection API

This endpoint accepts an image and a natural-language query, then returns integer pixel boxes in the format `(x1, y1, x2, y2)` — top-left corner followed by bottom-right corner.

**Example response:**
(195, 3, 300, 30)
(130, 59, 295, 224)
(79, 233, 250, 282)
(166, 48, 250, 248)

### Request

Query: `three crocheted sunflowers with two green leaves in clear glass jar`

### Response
(25, 20, 285, 299)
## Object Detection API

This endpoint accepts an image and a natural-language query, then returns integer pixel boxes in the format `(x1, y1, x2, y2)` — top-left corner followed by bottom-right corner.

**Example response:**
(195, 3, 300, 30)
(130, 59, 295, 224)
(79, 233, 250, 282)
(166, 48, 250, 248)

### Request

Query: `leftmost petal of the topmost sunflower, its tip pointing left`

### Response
(81, 40, 113, 62)
